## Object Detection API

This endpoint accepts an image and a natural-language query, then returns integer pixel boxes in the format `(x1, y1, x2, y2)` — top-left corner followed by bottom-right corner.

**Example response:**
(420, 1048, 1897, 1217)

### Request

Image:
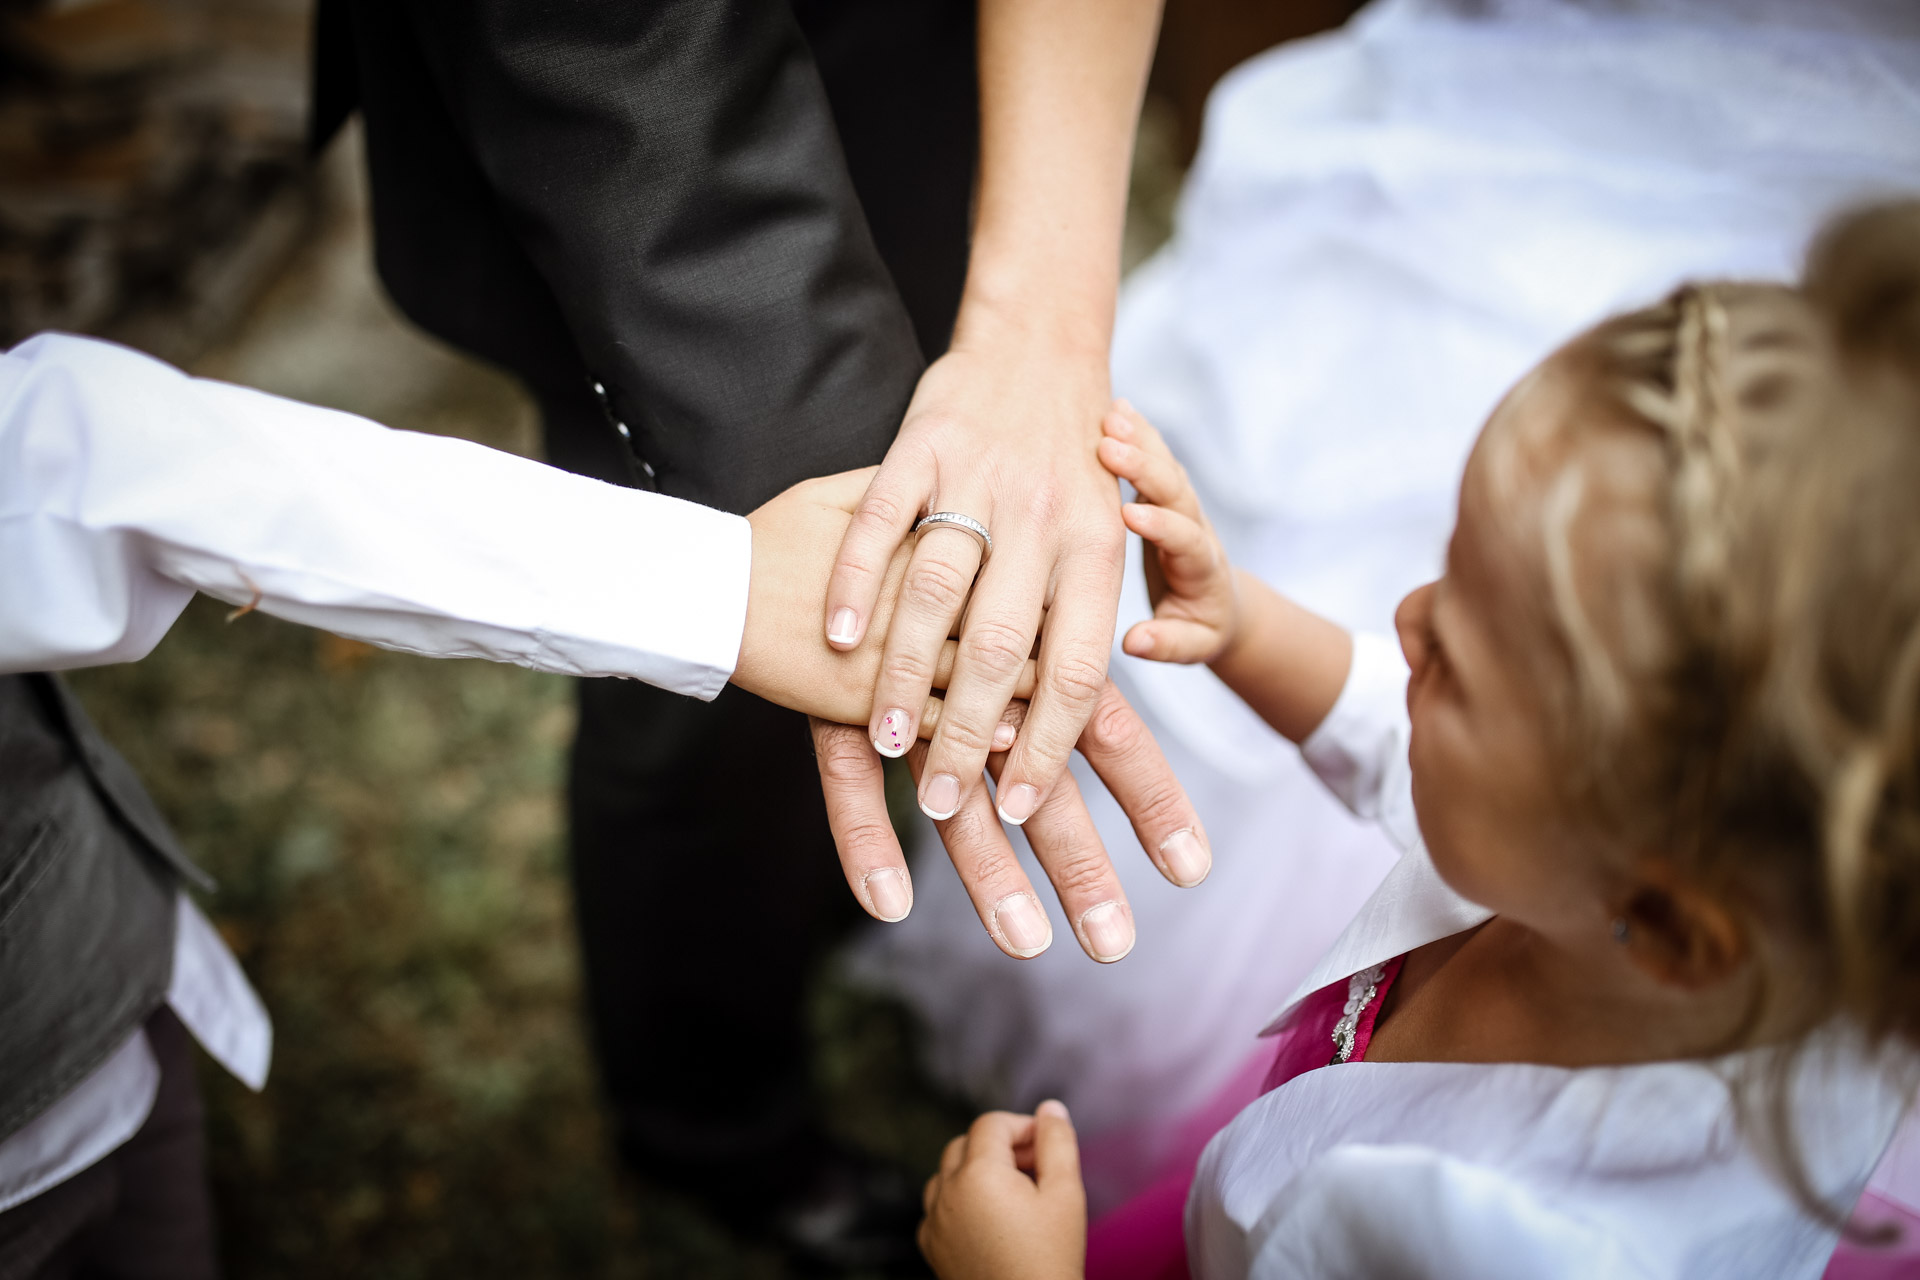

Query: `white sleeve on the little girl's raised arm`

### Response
(1300, 631, 1419, 852)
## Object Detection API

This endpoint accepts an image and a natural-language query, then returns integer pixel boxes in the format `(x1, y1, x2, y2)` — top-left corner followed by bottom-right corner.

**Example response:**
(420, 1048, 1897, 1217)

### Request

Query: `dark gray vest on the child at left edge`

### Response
(0, 676, 209, 1140)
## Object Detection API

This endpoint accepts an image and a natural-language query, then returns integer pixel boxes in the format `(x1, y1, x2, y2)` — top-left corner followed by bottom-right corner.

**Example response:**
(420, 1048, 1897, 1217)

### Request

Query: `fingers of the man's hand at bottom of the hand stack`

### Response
(812, 683, 1213, 951)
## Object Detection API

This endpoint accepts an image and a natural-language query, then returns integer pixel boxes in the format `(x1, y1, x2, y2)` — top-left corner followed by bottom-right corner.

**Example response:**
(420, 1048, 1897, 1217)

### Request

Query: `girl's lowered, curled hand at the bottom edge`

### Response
(920, 1102, 1087, 1280)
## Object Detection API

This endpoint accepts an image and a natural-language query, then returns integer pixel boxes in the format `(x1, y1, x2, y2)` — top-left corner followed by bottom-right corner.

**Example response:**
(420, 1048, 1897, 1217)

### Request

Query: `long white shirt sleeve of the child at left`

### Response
(0, 334, 753, 699)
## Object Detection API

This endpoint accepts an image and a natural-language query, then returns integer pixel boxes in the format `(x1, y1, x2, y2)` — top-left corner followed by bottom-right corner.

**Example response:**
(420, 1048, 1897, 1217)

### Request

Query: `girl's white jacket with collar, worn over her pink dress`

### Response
(1187, 639, 1901, 1280)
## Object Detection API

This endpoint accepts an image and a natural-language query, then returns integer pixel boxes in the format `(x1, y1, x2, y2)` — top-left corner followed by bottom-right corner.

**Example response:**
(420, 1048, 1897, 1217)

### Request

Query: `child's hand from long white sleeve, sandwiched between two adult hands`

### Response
(733, 466, 1033, 736)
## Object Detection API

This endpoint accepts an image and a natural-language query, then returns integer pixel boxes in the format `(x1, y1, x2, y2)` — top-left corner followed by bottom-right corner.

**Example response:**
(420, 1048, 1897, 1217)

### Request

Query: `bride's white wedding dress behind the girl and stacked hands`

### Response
(854, 0, 1920, 1209)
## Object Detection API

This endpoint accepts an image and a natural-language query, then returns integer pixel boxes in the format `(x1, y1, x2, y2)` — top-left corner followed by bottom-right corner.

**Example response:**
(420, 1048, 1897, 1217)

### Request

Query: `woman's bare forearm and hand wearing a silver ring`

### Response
(824, 0, 1160, 823)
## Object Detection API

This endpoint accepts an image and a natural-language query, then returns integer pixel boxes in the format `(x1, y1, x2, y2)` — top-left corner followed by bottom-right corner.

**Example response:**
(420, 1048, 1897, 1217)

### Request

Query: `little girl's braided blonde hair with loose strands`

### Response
(1538, 203, 1920, 1217)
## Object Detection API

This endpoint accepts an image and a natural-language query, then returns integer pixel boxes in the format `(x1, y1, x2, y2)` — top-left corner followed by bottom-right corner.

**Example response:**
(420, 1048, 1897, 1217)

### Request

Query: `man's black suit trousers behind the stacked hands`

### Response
(556, 0, 977, 1173)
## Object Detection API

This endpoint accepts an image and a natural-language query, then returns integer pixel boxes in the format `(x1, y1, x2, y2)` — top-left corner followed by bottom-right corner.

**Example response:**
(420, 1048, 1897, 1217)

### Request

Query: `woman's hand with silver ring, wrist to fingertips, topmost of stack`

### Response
(826, 330, 1125, 825)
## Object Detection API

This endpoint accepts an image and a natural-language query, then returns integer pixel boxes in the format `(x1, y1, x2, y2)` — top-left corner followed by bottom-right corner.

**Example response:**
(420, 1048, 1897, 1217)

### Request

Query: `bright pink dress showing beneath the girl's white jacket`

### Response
(1087, 956, 1920, 1280)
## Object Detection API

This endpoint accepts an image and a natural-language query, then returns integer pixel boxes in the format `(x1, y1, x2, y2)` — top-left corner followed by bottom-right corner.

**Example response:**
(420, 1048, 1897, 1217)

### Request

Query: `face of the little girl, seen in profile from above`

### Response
(1394, 374, 1607, 933)
